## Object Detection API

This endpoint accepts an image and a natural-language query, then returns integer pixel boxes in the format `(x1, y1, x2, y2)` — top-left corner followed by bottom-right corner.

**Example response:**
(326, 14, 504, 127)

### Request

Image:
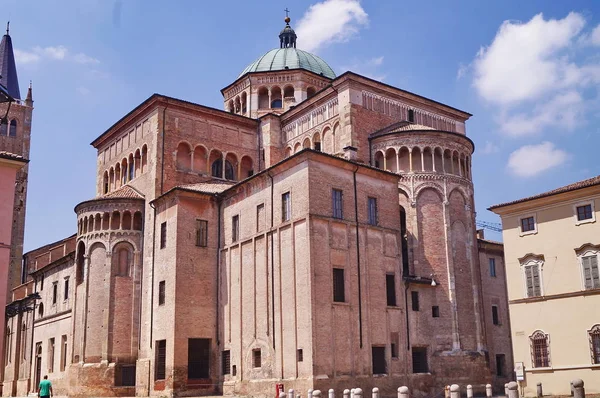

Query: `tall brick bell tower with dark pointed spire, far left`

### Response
(0, 22, 33, 299)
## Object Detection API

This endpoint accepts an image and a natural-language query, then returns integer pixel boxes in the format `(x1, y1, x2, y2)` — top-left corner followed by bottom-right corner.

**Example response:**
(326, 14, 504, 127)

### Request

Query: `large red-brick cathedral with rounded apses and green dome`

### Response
(0, 18, 512, 397)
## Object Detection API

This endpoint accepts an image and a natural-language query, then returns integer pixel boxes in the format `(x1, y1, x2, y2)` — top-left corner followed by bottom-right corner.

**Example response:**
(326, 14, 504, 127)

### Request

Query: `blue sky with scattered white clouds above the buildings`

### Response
(0, 0, 600, 250)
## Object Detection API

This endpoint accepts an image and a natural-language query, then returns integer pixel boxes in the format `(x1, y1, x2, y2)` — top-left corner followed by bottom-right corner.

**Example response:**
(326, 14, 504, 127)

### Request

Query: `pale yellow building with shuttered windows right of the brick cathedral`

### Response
(489, 176, 600, 396)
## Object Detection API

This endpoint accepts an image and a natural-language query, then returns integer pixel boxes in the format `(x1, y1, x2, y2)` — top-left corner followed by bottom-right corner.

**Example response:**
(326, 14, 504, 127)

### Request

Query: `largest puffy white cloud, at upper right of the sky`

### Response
(472, 12, 600, 136)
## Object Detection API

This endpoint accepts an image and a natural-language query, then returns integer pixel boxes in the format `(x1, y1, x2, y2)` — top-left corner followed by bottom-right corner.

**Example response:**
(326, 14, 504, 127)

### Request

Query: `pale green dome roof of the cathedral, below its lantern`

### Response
(238, 47, 335, 79)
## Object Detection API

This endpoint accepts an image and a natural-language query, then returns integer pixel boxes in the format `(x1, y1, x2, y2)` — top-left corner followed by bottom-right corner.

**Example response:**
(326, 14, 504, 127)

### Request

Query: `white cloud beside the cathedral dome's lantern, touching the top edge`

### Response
(295, 0, 369, 51)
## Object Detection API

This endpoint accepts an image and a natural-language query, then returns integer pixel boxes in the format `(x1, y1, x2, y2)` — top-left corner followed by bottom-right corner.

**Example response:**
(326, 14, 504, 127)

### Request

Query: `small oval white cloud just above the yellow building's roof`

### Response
(508, 141, 569, 177)
